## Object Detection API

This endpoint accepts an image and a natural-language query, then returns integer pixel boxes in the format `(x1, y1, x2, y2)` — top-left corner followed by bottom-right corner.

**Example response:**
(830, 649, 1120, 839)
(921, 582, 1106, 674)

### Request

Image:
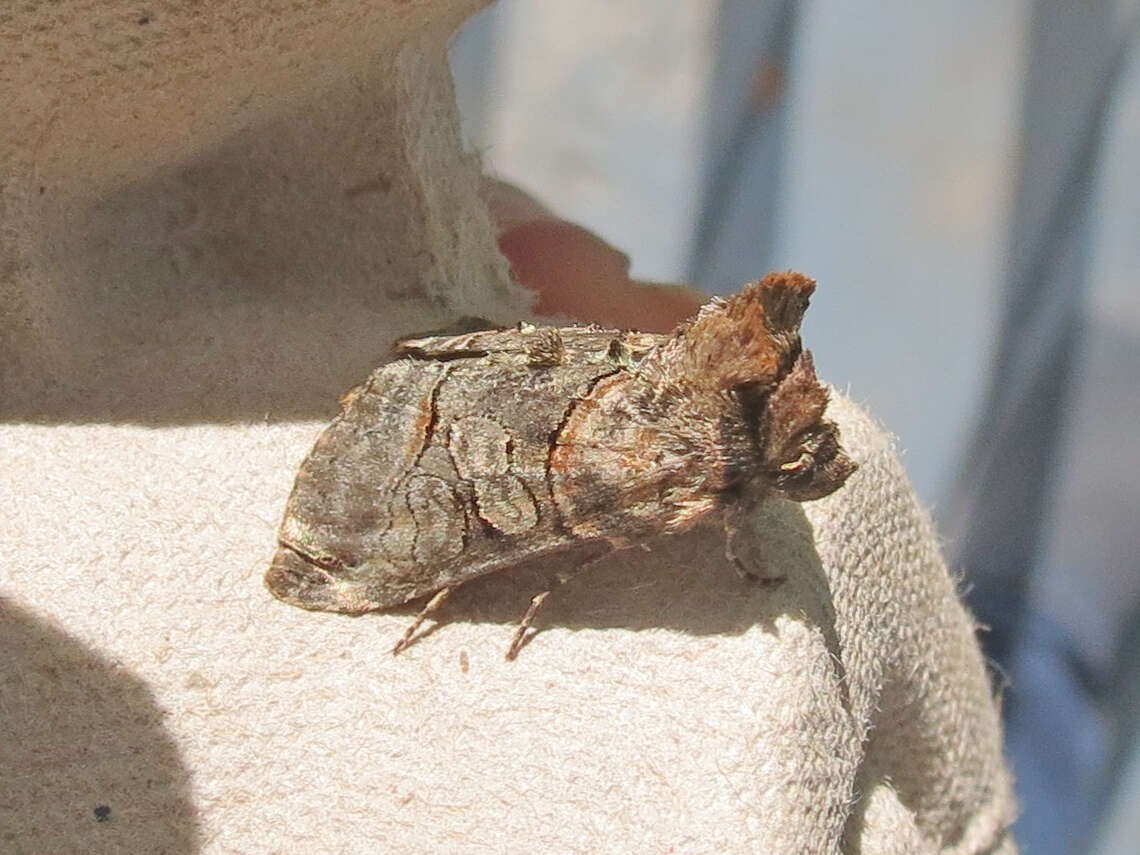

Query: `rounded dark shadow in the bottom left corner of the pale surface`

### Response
(0, 599, 201, 855)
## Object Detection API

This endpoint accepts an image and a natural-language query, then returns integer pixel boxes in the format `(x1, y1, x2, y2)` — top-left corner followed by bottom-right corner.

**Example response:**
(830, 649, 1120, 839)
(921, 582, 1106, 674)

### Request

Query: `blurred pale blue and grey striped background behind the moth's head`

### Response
(453, 0, 1140, 855)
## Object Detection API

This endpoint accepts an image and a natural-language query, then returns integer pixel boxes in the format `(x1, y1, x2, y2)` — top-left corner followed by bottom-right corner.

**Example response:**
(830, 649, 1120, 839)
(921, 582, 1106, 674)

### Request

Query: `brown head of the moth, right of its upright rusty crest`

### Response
(756, 350, 855, 502)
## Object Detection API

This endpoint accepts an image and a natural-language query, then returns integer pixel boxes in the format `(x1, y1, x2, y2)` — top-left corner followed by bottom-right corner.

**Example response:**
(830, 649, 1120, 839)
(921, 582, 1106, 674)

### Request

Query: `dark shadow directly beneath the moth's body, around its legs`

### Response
(401, 500, 834, 641)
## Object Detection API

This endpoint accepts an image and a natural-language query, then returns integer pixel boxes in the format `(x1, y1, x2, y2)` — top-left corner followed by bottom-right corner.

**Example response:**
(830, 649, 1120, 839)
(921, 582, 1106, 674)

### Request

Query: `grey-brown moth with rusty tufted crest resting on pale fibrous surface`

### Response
(266, 272, 855, 659)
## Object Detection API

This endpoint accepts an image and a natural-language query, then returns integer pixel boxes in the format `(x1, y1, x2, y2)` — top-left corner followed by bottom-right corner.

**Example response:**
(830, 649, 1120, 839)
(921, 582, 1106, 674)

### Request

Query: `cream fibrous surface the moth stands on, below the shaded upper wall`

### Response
(0, 402, 1010, 853)
